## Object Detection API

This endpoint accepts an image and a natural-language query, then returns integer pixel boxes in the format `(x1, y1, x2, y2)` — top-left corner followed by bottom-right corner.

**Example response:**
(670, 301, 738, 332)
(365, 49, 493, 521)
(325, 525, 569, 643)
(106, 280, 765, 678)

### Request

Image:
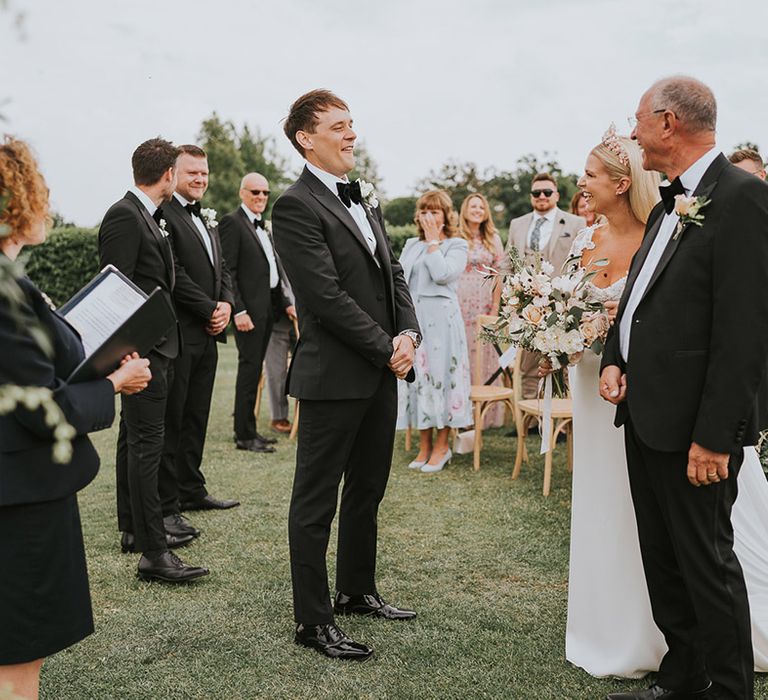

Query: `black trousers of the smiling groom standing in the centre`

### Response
(288, 369, 397, 625)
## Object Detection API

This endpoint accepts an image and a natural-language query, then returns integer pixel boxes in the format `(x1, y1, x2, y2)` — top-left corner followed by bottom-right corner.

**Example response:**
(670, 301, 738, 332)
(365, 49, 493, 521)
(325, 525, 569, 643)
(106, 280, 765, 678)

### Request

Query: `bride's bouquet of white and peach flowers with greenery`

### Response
(486, 246, 610, 396)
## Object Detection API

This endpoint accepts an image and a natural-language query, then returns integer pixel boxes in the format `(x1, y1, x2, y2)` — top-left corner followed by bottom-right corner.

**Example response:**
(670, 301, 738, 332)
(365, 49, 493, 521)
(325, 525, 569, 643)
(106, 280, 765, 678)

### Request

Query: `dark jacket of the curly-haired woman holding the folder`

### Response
(0, 272, 115, 506)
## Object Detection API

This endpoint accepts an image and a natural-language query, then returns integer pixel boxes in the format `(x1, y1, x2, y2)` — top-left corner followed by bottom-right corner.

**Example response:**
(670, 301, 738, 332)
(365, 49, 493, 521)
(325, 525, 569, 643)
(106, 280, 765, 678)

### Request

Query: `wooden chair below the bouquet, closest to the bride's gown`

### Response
(512, 353, 573, 496)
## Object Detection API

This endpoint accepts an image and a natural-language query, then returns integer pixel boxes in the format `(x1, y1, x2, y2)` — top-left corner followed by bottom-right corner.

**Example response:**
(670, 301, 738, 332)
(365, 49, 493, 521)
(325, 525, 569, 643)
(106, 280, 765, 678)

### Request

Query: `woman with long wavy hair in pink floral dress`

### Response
(459, 194, 507, 428)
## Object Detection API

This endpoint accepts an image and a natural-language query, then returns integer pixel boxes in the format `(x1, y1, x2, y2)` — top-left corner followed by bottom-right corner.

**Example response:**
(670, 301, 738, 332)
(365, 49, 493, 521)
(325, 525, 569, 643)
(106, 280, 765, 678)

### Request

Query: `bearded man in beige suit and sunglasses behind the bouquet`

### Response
(507, 173, 587, 399)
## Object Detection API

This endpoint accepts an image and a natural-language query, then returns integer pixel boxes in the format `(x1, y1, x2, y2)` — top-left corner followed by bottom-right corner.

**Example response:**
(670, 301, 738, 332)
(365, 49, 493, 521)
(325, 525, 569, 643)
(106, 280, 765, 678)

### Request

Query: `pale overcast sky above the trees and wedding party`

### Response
(0, 0, 768, 225)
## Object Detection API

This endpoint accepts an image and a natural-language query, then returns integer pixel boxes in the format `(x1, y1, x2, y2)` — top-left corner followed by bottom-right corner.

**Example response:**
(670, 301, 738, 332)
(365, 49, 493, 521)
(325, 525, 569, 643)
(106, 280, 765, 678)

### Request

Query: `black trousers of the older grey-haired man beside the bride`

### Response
(617, 418, 754, 700)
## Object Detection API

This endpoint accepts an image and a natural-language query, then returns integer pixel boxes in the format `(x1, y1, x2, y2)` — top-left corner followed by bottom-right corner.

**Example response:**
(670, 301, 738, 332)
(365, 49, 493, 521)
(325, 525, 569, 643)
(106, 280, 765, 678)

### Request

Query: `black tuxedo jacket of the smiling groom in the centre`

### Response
(272, 168, 419, 399)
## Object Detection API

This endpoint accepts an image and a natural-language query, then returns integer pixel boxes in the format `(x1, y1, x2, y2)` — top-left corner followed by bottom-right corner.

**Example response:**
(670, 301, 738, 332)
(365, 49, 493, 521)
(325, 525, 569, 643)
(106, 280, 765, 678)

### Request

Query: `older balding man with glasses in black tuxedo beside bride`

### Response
(600, 77, 768, 700)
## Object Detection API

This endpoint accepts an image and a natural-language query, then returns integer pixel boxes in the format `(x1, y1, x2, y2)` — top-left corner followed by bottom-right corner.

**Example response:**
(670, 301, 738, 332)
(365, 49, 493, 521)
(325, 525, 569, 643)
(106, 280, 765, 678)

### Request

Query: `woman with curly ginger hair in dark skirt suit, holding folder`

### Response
(0, 138, 151, 698)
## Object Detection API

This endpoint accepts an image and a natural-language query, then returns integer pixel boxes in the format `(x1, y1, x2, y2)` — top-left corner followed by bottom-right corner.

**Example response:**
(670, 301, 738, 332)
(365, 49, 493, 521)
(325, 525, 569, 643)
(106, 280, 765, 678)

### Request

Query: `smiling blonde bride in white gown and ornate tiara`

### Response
(565, 130, 768, 678)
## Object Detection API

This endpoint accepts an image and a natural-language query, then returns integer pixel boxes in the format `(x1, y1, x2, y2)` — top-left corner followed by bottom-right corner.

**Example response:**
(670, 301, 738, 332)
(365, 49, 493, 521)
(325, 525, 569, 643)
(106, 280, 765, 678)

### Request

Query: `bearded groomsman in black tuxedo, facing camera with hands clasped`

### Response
(160, 145, 239, 537)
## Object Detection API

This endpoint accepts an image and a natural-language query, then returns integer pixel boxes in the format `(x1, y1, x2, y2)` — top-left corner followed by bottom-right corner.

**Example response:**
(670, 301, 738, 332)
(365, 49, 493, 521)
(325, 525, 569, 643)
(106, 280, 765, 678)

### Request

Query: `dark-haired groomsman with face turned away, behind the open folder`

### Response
(99, 138, 208, 583)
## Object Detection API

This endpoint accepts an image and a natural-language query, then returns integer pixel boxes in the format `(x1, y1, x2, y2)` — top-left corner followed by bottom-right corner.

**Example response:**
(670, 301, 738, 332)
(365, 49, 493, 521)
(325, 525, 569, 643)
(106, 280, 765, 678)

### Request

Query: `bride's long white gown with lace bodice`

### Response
(565, 229, 768, 678)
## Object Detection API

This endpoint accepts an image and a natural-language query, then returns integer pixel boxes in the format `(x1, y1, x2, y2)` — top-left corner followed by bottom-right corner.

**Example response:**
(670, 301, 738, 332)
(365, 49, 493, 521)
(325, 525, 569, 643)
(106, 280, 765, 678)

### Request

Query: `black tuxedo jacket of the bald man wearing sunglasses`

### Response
(219, 207, 291, 323)
